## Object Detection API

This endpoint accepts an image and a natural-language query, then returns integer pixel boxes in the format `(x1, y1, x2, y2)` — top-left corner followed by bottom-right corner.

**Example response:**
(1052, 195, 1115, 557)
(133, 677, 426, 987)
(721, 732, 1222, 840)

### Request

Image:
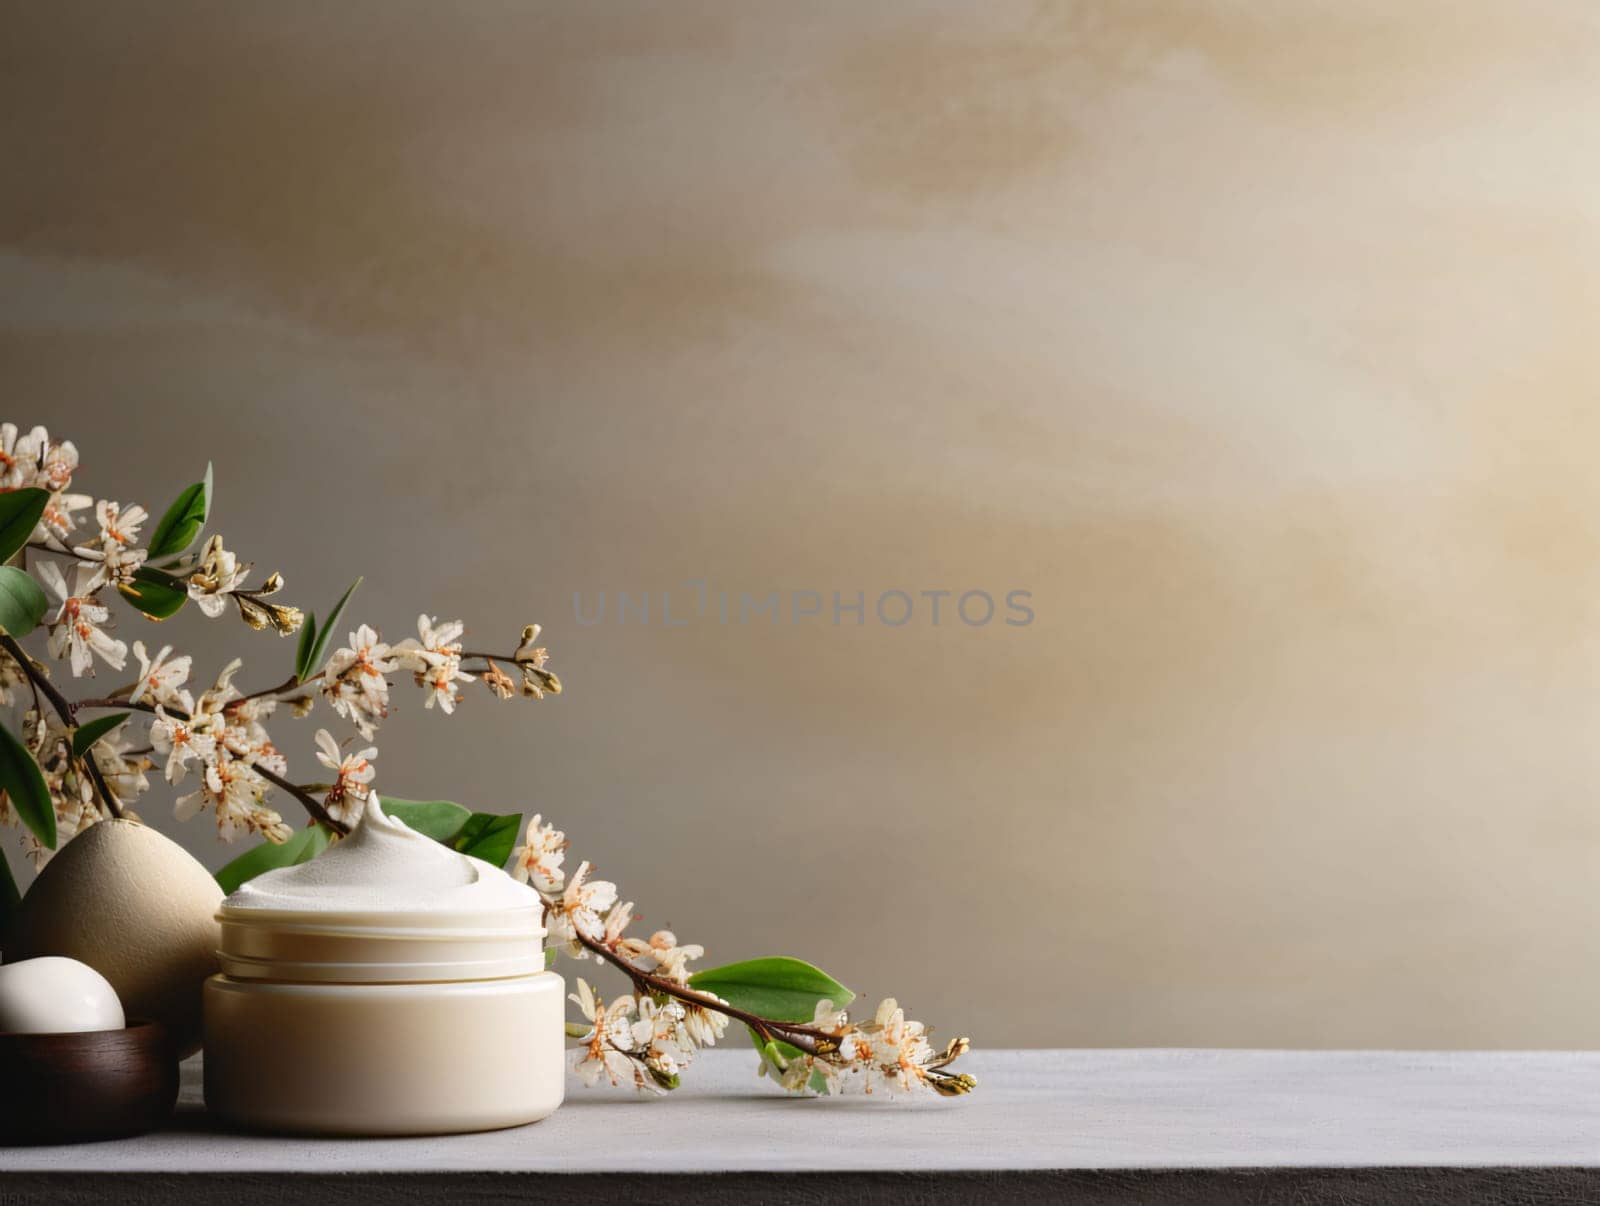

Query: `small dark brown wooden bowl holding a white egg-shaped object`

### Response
(0, 1022, 178, 1144)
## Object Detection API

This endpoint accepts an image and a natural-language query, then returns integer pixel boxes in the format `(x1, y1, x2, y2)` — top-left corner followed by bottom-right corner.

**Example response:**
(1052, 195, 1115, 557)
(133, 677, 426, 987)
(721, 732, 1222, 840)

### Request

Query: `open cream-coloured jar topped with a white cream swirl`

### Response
(205, 795, 563, 1136)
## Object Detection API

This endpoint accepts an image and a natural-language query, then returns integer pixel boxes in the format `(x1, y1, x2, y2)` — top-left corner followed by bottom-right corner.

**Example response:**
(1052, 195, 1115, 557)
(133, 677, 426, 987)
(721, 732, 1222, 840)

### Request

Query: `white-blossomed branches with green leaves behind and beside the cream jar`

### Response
(0, 424, 976, 1096)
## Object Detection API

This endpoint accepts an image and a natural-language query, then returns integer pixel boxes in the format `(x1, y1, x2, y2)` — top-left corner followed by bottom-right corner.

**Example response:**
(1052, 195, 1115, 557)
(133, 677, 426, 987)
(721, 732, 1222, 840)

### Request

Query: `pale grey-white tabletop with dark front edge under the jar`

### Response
(0, 1049, 1600, 1206)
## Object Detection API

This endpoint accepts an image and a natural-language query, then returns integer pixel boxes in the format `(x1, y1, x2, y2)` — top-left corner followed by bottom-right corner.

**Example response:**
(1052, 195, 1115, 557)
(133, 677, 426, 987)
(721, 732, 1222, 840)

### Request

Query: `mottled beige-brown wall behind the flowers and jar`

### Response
(0, 0, 1600, 1046)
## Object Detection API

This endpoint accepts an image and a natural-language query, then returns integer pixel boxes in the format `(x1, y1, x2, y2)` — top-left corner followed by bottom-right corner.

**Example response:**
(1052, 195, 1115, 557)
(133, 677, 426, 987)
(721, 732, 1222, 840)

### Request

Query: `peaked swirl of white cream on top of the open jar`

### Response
(222, 792, 539, 913)
